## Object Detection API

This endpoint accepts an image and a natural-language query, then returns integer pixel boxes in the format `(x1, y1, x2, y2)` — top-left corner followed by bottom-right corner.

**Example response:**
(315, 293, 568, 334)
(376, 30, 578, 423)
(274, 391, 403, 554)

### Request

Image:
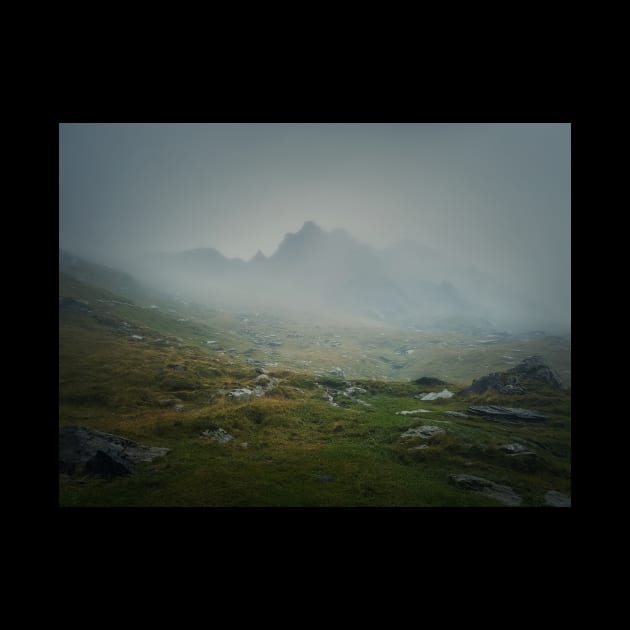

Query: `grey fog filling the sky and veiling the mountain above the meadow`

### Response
(59, 123, 571, 334)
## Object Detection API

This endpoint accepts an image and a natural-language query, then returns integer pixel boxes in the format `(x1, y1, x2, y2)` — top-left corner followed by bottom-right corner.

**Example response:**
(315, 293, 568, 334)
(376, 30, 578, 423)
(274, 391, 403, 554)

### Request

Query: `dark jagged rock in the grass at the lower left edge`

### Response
(59, 426, 170, 477)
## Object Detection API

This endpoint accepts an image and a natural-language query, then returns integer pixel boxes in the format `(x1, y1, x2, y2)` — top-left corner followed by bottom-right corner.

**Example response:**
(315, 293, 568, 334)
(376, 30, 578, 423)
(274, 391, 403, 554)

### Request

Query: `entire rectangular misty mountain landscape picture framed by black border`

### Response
(58, 122, 571, 509)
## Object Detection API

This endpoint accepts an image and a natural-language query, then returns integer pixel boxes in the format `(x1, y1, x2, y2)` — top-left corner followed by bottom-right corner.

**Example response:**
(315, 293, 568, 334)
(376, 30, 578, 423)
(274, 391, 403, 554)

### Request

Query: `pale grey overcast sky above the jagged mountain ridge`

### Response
(59, 123, 571, 320)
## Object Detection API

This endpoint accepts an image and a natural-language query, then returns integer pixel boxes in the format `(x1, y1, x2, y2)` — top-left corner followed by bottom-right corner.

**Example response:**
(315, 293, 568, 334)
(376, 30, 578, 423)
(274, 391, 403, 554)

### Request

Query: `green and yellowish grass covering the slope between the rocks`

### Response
(59, 274, 571, 507)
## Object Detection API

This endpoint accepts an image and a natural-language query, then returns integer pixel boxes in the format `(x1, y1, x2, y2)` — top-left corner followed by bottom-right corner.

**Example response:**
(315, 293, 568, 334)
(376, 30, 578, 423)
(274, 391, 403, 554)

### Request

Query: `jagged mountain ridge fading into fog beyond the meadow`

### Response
(121, 221, 564, 332)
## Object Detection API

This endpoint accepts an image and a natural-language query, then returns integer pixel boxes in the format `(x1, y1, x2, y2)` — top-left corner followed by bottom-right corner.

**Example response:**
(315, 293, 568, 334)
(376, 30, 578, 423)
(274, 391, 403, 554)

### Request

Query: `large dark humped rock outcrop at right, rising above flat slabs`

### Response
(466, 355, 562, 394)
